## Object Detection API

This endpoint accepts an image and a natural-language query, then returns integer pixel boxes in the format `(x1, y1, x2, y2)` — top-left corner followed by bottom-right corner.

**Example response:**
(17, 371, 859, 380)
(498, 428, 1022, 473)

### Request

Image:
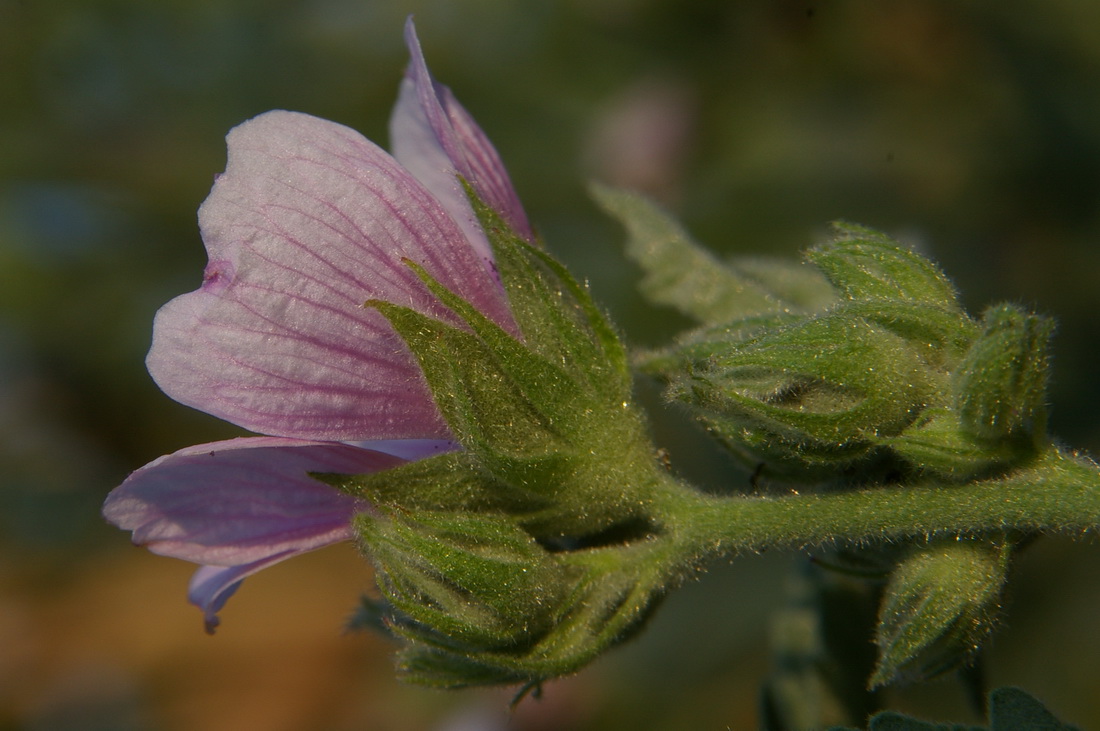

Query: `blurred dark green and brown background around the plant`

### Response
(0, 0, 1100, 731)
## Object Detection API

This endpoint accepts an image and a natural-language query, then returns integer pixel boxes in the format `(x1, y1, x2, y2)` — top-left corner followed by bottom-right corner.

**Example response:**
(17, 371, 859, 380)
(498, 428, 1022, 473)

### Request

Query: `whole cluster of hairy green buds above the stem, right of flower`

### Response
(644, 225, 1052, 480)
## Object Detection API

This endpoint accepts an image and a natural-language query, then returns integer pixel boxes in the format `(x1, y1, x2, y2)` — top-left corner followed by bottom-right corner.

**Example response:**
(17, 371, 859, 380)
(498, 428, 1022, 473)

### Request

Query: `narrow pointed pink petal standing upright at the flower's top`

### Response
(389, 18, 534, 262)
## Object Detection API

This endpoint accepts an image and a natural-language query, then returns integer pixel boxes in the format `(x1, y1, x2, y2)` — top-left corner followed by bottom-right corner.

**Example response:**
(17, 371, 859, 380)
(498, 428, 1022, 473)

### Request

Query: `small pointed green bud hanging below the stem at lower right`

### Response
(870, 540, 1009, 688)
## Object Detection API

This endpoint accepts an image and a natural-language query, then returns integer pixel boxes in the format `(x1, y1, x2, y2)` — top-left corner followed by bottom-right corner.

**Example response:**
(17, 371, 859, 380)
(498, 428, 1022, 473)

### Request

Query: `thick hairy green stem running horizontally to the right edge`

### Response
(657, 447, 1100, 558)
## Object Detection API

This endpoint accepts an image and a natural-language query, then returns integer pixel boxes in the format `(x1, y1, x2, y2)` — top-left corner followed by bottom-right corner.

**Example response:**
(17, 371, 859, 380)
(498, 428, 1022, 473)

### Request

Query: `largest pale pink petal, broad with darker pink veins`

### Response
(146, 111, 515, 441)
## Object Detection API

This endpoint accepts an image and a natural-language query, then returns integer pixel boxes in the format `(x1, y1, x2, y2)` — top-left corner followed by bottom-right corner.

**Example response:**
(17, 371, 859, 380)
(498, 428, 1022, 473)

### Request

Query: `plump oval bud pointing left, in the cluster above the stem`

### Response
(669, 306, 943, 478)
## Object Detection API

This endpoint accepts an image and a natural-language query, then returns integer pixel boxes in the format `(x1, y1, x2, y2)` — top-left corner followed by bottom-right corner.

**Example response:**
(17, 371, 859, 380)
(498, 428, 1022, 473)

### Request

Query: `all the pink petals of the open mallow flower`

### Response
(103, 21, 531, 631)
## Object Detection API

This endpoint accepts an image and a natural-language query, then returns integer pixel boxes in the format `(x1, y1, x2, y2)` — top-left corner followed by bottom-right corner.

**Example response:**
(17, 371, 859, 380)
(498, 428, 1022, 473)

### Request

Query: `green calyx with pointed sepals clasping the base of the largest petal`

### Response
(369, 192, 659, 538)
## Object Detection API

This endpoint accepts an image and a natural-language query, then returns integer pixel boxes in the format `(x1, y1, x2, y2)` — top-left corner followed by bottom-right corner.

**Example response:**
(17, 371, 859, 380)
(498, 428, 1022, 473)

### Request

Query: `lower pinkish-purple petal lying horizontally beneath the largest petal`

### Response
(103, 438, 405, 567)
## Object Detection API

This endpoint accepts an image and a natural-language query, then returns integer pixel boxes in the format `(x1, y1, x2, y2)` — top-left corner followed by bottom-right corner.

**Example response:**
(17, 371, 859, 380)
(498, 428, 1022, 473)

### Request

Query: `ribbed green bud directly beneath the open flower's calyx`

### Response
(364, 514, 670, 687)
